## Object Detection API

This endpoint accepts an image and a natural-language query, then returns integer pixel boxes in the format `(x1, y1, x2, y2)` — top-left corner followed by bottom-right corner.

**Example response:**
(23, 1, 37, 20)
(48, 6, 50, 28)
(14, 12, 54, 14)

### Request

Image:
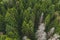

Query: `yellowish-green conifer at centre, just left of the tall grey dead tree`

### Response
(22, 7, 35, 37)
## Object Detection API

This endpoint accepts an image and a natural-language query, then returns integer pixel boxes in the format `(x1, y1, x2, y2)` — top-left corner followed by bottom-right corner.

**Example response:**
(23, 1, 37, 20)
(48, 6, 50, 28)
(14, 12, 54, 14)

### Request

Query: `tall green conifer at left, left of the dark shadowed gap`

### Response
(5, 8, 19, 40)
